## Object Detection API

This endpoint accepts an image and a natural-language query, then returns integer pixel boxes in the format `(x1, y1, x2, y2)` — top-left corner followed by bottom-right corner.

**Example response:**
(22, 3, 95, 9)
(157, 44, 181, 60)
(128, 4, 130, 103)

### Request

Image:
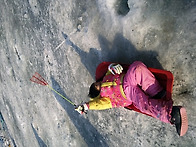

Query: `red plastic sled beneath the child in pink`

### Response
(95, 62, 174, 115)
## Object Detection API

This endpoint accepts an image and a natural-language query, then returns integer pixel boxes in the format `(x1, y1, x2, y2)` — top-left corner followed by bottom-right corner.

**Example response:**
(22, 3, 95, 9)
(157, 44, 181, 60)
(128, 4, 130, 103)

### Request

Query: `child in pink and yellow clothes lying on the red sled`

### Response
(75, 61, 188, 136)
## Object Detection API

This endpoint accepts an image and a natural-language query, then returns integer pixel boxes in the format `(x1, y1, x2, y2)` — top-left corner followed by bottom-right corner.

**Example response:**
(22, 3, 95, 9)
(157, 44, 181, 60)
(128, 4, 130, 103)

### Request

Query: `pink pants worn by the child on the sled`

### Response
(123, 61, 173, 123)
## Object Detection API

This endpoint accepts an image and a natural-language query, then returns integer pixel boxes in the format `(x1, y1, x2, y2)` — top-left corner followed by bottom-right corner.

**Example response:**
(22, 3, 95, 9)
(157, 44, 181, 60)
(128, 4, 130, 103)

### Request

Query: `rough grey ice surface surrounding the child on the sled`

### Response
(0, 0, 196, 147)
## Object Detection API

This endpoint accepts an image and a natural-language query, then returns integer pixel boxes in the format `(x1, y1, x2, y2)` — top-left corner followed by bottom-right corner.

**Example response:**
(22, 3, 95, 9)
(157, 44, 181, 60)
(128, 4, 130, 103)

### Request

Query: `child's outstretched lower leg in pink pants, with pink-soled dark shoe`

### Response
(125, 83, 188, 136)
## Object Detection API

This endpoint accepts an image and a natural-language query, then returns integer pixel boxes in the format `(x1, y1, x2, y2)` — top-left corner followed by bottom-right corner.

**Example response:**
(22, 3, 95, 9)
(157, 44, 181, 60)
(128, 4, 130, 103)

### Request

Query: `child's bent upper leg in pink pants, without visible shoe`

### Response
(124, 61, 163, 97)
